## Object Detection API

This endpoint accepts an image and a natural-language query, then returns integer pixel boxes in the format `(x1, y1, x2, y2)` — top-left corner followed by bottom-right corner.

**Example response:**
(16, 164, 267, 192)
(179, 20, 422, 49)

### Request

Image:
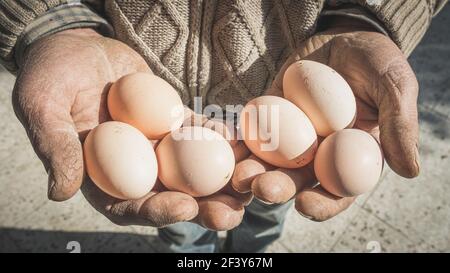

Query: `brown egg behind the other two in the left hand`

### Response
(108, 72, 184, 140)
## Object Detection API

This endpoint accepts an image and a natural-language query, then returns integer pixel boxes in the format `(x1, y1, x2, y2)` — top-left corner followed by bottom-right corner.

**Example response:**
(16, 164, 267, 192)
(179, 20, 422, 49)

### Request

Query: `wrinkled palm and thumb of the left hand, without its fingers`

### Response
(13, 29, 149, 201)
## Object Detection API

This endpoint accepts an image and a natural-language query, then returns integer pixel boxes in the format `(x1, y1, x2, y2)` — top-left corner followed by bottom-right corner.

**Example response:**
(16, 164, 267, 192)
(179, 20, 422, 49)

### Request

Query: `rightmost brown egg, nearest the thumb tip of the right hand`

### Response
(314, 129, 383, 197)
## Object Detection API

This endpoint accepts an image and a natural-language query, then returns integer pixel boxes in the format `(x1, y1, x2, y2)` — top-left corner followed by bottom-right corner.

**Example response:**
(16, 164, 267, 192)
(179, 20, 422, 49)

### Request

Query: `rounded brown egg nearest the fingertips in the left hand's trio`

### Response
(156, 127, 235, 197)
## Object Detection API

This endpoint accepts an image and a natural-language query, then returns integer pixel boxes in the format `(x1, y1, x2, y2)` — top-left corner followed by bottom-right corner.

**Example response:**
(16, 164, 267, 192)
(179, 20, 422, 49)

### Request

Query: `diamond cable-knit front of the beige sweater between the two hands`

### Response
(105, 0, 323, 105)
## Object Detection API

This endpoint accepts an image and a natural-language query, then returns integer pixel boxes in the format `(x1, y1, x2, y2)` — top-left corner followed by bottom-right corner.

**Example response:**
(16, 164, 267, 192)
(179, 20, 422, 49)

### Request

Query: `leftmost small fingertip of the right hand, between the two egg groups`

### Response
(231, 155, 275, 193)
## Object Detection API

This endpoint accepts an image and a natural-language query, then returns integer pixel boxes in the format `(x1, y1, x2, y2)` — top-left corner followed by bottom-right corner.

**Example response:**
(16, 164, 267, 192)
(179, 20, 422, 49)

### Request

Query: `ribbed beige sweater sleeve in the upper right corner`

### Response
(325, 0, 447, 56)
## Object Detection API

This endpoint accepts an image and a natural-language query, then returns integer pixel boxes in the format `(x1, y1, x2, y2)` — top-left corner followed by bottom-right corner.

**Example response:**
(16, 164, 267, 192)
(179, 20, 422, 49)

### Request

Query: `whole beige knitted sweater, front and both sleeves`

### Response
(0, 0, 446, 106)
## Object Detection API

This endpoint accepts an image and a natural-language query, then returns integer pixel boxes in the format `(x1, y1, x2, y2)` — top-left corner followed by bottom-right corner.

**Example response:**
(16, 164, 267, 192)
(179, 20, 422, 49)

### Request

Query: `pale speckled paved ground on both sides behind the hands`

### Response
(0, 6, 450, 252)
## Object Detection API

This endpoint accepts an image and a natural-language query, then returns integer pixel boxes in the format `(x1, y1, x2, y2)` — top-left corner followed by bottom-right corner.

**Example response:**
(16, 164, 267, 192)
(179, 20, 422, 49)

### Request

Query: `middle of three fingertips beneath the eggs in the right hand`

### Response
(252, 165, 316, 204)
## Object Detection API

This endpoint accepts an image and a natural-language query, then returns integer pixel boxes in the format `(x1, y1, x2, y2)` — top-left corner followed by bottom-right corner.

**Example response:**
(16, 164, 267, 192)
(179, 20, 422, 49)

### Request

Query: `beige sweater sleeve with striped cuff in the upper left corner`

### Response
(0, 0, 112, 73)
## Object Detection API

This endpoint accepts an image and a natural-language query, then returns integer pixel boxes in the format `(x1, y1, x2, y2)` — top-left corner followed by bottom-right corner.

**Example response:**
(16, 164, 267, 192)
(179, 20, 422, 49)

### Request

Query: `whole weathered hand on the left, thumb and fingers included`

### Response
(13, 29, 250, 230)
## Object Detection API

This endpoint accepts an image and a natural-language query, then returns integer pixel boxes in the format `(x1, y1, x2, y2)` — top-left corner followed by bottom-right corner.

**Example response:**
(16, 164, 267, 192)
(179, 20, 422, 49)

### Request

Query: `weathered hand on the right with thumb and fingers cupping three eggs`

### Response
(233, 22, 419, 221)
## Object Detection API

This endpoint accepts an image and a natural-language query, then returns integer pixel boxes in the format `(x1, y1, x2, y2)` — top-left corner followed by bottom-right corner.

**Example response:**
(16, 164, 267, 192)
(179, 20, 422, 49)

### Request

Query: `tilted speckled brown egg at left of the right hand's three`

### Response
(240, 96, 317, 168)
